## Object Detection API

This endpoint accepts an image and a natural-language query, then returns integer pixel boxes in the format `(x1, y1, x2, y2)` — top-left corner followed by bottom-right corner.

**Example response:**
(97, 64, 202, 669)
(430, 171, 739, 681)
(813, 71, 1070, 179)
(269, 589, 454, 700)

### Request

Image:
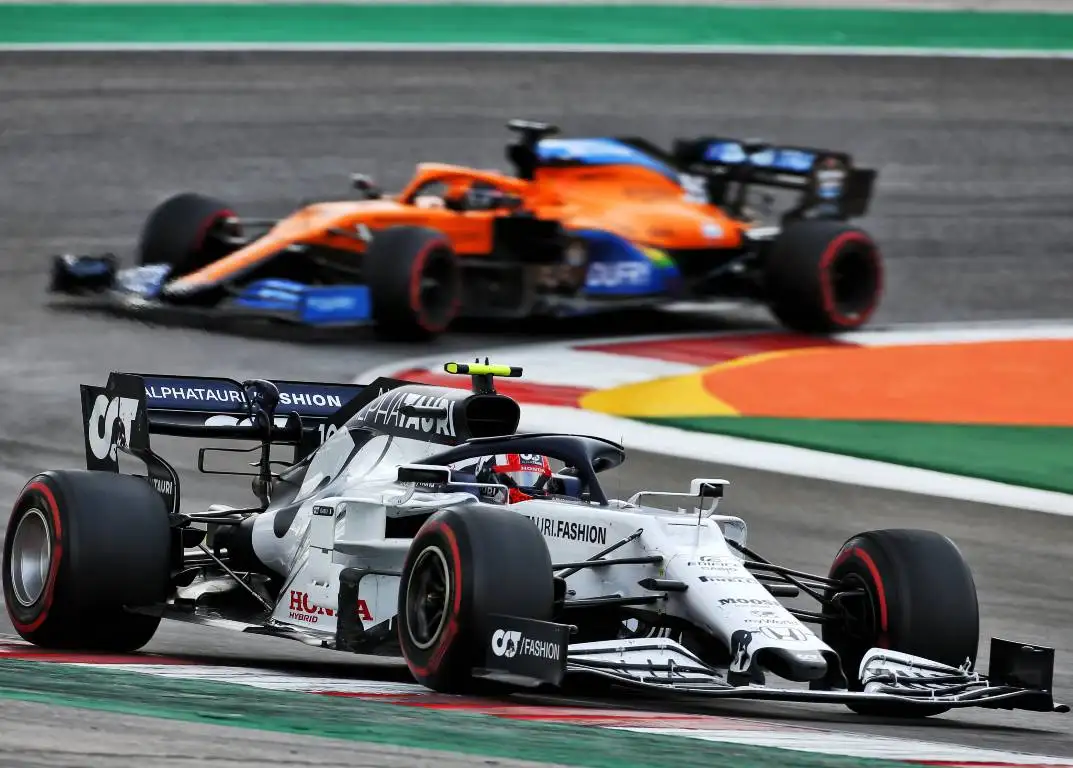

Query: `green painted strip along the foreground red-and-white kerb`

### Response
(0, 660, 922, 768)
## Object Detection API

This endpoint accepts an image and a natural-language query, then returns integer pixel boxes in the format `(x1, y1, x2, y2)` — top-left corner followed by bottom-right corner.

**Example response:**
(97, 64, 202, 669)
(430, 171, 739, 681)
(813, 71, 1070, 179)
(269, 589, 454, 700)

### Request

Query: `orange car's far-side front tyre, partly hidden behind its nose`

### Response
(137, 192, 241, 277)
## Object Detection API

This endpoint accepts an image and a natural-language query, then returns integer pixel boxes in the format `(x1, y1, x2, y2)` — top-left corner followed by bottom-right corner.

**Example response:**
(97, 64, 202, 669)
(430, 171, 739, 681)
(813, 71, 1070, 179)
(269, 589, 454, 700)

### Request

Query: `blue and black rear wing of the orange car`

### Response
(672, 136, 878, 219)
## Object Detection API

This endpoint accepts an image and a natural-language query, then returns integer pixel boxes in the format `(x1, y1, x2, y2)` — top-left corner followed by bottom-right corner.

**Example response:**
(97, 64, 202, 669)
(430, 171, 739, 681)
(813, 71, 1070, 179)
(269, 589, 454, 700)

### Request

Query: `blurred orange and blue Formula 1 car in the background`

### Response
(50, 120, 883, 339)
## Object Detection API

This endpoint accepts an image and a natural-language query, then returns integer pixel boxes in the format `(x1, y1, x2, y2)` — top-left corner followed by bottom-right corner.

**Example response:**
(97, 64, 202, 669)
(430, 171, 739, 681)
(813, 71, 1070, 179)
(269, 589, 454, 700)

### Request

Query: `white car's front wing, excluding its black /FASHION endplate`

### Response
(567, 638, 1070, 712)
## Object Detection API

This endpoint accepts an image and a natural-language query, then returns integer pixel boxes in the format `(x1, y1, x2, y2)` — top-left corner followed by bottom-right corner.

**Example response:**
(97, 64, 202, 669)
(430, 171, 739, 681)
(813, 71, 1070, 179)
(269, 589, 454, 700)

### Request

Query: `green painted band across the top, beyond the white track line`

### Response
(6, 3, 1073, 51)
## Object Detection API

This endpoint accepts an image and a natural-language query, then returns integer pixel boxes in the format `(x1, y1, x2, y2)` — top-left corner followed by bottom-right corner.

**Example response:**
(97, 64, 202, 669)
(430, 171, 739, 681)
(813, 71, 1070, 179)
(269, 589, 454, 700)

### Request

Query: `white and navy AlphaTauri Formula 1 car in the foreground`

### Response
(3, 364, 1069, 715)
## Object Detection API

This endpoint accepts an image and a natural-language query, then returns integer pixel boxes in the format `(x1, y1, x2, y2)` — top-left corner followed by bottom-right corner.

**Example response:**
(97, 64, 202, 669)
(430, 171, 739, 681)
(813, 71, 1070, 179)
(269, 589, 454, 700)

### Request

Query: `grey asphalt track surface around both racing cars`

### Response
(0, 54, 1073, 765)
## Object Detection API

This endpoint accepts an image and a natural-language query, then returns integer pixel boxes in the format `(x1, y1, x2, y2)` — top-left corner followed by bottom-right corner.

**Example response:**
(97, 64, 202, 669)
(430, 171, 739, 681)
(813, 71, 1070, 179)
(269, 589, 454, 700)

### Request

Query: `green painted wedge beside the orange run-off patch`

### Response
(642, 416, 1073, 493)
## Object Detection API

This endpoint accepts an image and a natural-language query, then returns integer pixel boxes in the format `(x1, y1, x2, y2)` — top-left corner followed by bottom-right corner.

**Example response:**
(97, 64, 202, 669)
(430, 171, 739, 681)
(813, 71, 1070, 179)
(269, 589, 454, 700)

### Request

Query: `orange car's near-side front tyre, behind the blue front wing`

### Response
(363, 226, 461, 341)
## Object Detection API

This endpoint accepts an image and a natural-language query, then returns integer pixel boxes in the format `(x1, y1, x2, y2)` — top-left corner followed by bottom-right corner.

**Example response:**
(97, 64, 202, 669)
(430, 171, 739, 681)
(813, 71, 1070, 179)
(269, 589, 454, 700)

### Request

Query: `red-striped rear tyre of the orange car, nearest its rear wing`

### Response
(764, 221, 883, 334)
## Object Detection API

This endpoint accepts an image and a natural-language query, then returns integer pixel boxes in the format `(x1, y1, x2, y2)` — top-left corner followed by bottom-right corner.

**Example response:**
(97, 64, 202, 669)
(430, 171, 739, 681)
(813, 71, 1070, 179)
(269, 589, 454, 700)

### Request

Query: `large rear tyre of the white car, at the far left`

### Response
(3, 470, 171, 652)
